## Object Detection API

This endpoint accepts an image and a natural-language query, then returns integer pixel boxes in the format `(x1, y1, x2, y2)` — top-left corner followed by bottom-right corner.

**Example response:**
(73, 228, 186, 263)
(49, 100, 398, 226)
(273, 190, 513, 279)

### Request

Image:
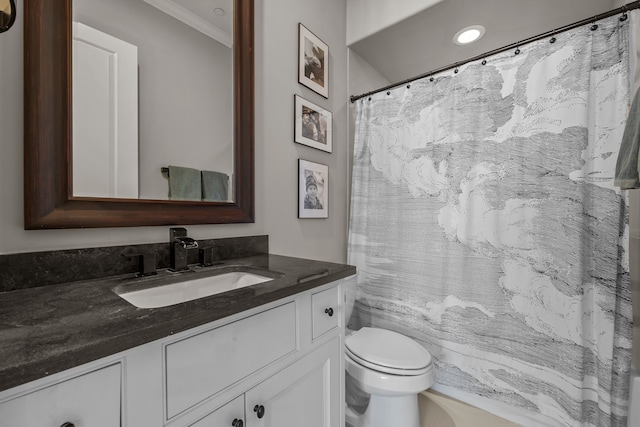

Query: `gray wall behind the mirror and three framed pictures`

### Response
(0, 0, 348, 262)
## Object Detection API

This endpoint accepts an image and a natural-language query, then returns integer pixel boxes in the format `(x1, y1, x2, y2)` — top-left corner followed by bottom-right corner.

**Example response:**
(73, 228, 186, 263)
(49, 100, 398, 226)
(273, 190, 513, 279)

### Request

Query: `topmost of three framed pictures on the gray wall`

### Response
(298, 24, 329, 98)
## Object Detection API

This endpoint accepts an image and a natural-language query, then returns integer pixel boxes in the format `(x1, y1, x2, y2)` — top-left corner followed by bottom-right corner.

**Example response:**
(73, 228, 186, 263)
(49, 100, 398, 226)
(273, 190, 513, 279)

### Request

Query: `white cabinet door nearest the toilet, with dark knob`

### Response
(246, 337, 341, 427)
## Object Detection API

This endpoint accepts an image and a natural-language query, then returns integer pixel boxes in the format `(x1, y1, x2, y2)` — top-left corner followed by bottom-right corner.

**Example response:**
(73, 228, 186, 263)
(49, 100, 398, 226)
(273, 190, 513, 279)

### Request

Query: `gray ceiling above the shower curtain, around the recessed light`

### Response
(350, 0, 624, 83)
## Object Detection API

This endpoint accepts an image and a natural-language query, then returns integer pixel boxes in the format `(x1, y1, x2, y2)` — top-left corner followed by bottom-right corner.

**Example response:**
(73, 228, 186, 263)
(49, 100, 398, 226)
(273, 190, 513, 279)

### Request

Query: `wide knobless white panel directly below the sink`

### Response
(165, 301, 298, 419)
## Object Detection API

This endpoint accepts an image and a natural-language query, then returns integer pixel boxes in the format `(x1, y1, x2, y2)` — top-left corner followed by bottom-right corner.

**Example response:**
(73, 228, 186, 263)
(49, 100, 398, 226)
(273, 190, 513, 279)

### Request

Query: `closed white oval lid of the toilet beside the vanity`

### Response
(345, 328, 431, 371)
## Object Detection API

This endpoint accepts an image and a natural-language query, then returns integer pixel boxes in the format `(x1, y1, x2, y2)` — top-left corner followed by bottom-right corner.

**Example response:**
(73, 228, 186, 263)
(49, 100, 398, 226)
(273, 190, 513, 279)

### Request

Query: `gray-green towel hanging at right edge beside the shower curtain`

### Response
(614, 91, 640, 190)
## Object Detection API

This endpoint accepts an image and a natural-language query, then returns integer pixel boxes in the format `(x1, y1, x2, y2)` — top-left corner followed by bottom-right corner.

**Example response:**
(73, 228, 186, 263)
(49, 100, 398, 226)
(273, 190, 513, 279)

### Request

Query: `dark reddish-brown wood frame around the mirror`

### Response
(24, 0, 255, 230)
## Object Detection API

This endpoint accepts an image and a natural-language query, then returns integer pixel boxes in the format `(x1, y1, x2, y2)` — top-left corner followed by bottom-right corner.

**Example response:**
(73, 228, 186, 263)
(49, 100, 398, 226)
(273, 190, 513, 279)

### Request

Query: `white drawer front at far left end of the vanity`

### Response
(0, 363, 121, 427)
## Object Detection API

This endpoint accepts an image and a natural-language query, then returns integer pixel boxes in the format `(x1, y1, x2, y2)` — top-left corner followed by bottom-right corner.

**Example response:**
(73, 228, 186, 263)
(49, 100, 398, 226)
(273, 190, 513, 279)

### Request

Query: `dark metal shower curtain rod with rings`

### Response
(351, 0, 640, 103)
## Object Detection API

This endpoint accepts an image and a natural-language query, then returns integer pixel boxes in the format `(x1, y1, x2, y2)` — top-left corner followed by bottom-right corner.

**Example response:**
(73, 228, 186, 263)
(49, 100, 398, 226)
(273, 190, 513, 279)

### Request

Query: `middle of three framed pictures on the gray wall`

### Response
(293, 95, 333, 153)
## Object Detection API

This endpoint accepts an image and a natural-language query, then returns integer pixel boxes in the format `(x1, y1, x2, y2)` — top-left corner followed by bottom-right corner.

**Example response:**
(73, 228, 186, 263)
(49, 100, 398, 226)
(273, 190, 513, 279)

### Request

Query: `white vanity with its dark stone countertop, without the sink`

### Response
(0, 255, 355, 427)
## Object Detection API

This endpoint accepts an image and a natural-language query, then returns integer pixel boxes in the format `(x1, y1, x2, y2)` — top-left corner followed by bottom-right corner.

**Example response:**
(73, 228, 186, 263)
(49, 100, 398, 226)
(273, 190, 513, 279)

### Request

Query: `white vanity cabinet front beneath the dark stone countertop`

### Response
(0, 276, 354, 427)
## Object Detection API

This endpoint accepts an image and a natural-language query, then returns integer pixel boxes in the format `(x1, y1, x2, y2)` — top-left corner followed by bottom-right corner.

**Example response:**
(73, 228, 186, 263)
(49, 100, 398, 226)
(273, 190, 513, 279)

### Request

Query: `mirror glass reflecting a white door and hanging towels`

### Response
(72, 0, 233, 202)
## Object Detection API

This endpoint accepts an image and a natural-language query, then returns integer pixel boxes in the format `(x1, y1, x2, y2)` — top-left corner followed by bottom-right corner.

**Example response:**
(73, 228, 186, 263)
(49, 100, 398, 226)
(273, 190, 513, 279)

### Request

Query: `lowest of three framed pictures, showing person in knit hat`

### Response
(298, 159, 329, 218)
